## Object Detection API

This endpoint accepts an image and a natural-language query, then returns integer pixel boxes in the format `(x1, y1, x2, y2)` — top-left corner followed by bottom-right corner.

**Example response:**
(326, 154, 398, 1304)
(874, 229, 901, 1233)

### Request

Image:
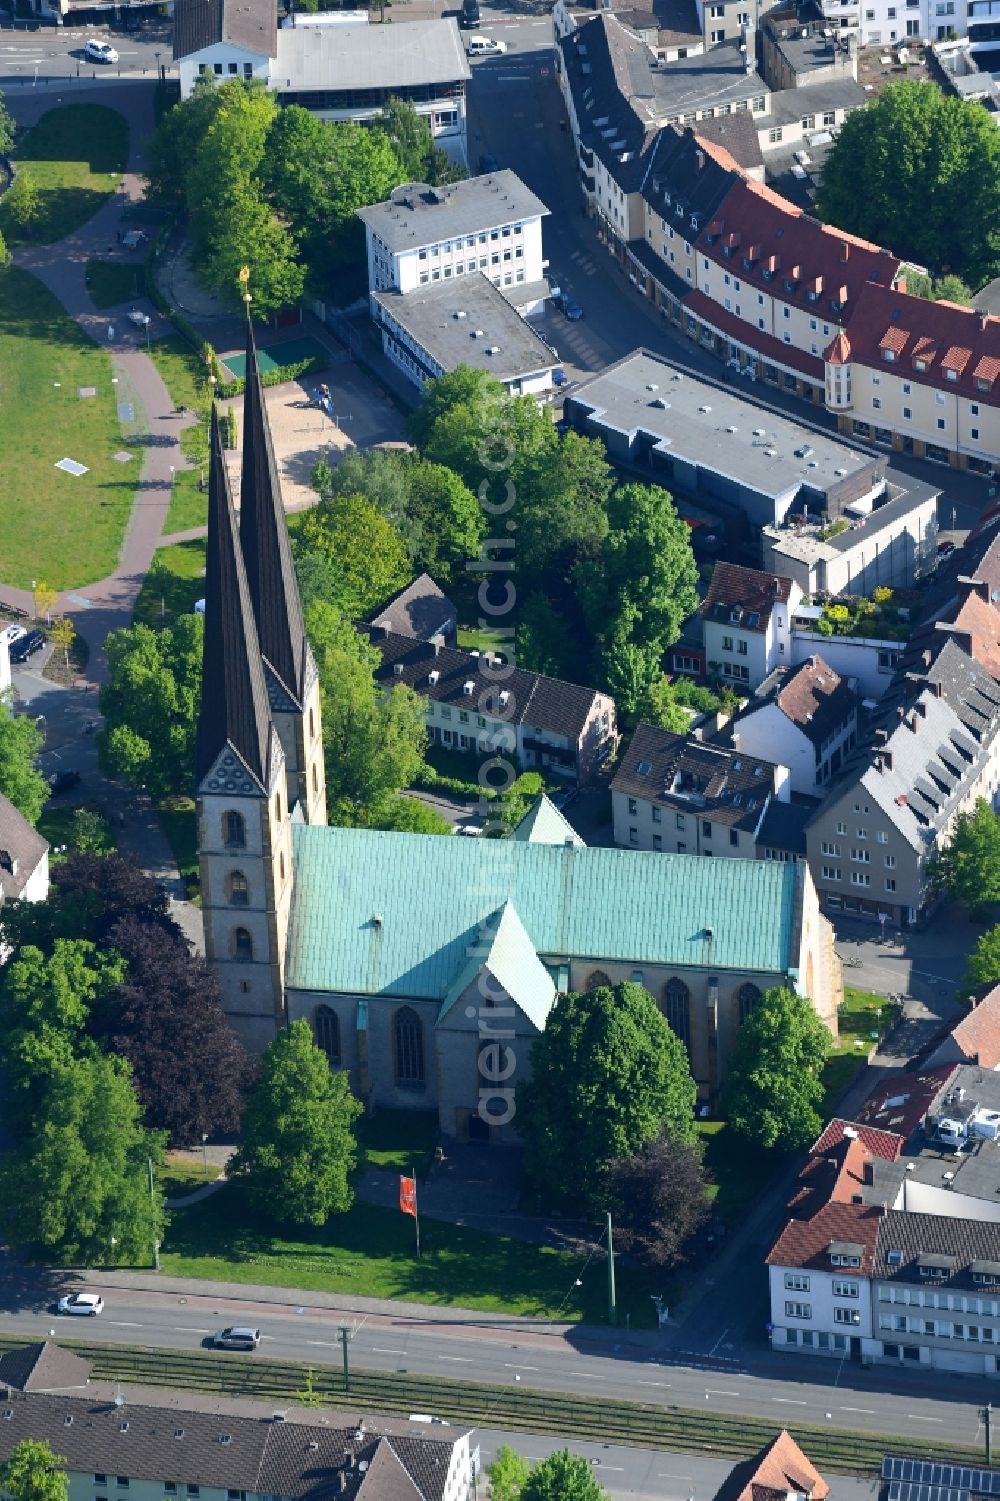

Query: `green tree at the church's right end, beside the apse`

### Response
(722, 989, 830, 1151)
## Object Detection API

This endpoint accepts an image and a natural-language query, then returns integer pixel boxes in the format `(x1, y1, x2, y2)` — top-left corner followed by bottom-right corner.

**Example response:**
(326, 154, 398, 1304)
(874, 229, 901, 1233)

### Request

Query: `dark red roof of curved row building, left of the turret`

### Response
(698, 179, 899, 325)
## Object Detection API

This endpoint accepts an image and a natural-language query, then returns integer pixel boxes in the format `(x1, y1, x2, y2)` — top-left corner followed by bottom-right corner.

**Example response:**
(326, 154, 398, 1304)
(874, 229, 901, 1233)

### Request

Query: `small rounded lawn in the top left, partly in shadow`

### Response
(0, 104, 129, 245)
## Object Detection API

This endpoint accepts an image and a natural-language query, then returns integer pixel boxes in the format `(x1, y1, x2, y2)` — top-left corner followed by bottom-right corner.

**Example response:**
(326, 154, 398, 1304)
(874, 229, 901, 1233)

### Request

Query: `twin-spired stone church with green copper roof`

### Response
(197, 330, 842, 1139)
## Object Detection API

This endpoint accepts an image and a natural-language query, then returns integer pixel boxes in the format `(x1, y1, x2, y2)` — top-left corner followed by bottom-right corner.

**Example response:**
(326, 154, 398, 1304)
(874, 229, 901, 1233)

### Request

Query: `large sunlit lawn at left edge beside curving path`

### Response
(0, 267, 137, 590)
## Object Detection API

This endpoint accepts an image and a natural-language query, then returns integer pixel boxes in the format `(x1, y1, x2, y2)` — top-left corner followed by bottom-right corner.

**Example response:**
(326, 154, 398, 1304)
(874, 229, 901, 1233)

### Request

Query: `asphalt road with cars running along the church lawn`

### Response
(7, 1273, 983, 1444)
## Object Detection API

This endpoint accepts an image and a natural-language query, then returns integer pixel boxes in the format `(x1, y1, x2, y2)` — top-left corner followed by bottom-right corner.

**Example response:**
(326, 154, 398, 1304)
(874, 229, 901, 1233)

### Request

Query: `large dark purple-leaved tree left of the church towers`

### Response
(92, 917, 255, 1147)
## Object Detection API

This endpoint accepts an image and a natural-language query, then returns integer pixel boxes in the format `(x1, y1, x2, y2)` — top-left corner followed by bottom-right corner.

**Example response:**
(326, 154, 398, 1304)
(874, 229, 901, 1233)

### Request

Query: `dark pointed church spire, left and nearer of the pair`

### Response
(197, 407, 270, 793)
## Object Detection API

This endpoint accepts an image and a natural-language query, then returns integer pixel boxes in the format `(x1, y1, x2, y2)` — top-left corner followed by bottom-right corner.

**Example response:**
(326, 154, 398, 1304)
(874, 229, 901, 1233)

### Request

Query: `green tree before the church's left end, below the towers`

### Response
(230, 1021, 362, 1225)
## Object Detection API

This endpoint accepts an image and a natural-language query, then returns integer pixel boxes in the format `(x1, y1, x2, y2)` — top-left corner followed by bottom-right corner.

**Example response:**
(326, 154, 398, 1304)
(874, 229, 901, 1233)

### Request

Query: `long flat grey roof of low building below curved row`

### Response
(568, 350, 872, 498)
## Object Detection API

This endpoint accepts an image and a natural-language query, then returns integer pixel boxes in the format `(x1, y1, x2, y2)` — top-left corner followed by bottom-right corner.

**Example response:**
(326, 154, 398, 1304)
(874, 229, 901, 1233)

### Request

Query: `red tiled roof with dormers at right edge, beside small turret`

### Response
(847, 282, 1000, 407)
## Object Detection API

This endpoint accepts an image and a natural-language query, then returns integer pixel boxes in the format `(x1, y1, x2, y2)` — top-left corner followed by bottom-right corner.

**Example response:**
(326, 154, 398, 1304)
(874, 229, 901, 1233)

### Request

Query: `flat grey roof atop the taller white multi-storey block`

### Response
(355, 171, 548, 251)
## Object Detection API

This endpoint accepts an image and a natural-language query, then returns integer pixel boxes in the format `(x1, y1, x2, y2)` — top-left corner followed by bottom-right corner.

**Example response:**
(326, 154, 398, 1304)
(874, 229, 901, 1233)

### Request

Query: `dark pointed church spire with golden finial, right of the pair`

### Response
(240, 318, 306, 710)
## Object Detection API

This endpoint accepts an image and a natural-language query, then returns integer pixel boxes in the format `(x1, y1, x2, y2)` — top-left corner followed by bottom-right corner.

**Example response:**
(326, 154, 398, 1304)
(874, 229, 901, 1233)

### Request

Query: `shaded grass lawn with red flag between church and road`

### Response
(161, 1184, 664, 1328)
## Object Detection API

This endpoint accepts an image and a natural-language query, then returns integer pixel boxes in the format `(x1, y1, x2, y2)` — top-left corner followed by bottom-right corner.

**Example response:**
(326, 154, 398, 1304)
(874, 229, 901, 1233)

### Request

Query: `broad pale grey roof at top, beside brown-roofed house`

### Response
(275, 17, 470, 93)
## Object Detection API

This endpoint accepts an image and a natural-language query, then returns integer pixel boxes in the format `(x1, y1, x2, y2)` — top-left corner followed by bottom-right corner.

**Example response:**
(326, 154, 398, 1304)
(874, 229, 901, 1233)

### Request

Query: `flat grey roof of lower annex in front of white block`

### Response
(372, 272, 559, 381)
